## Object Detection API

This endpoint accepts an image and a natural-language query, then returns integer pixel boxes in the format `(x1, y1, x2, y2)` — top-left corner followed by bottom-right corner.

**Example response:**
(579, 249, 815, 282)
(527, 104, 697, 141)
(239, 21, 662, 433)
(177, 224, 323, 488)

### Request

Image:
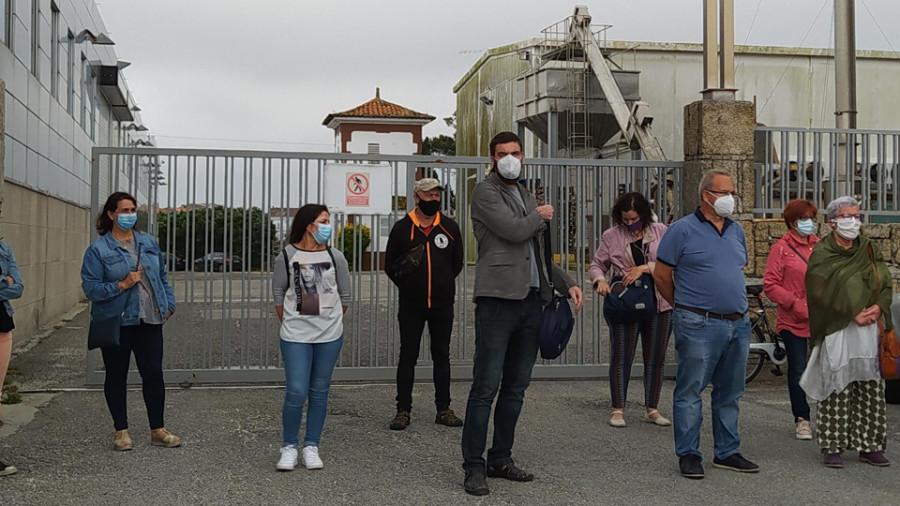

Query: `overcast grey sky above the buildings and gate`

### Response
(99, 0, 900, 152)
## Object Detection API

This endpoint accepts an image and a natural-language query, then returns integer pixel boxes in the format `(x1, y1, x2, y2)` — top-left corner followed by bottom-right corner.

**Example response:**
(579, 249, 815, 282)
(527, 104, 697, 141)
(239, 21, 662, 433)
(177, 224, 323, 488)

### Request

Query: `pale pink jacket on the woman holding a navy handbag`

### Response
(588, 223, 672, 313)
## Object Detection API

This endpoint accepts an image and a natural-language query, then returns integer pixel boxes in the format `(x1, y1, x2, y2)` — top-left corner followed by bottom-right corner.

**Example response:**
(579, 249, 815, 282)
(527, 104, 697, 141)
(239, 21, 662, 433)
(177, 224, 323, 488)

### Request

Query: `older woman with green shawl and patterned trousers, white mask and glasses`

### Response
(800, 197, 893, 468)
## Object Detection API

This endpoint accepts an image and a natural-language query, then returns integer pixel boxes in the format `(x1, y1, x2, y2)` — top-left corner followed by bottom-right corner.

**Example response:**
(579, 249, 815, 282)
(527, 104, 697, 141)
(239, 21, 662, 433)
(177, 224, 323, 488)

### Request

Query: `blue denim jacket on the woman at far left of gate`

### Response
(81, 231, 175, 326)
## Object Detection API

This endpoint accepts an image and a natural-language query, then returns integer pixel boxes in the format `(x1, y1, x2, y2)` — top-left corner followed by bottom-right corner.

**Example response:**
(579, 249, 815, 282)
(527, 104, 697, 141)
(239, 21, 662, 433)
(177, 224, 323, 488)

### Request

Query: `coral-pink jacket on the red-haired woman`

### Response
(763, 232, 819, 337)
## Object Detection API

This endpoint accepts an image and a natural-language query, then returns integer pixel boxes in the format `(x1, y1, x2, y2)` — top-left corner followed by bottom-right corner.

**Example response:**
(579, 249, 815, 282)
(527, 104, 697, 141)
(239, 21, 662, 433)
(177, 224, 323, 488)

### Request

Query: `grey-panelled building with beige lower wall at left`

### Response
(0, 0, 152, 340)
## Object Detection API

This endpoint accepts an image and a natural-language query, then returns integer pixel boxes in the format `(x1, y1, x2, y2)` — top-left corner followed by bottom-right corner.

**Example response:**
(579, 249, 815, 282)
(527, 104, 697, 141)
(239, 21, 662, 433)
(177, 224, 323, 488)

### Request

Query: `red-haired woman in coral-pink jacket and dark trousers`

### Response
(763, 199, 819, 439)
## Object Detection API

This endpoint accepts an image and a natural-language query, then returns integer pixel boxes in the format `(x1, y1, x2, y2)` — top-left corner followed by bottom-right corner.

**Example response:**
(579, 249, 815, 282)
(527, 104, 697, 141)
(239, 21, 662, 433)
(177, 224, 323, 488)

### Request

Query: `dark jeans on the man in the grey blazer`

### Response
(462, 291, 543, 470)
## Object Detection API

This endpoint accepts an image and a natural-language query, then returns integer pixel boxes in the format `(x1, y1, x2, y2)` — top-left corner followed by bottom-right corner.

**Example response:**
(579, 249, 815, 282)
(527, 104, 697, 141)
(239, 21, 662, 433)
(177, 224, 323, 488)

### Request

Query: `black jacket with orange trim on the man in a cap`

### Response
(384, 210, 463, 307)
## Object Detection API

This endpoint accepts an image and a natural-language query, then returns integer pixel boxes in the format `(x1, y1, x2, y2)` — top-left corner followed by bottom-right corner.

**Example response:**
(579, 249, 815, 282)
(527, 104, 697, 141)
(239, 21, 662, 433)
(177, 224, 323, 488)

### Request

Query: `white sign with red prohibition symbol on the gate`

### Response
(324, 163, 393, 214)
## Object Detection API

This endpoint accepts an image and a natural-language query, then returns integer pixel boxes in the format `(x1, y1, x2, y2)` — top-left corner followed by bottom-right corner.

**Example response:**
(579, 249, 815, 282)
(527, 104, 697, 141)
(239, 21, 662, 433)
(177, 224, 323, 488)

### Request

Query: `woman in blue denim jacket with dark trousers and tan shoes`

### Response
(81, 192, 181, 450)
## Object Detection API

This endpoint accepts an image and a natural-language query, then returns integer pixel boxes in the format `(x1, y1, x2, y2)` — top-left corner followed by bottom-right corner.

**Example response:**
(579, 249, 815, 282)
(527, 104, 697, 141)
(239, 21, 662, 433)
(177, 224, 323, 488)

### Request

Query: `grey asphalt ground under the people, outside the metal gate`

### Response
(0, 304, 900, 506)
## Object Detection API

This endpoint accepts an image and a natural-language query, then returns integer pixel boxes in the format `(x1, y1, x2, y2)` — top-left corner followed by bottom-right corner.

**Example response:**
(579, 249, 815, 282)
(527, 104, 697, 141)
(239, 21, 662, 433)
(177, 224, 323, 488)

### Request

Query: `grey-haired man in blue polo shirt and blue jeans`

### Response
(653, 171, 759, 479)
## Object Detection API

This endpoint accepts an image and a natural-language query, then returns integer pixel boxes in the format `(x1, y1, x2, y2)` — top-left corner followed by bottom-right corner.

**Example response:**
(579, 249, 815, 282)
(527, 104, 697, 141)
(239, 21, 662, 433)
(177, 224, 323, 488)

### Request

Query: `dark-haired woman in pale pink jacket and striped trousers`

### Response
(588, 193, 672, 427)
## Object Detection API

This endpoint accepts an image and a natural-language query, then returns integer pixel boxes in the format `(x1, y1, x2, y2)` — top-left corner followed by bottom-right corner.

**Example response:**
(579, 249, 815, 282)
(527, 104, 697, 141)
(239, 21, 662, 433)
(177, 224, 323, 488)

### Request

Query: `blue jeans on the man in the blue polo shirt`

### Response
(672, 308, 750, 459)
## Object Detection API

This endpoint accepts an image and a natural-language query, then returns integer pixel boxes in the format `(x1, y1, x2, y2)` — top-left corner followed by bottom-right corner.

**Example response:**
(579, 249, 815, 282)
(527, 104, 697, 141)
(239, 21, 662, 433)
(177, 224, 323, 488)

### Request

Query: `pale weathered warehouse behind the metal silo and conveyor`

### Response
(453, 34, 900, 160)
